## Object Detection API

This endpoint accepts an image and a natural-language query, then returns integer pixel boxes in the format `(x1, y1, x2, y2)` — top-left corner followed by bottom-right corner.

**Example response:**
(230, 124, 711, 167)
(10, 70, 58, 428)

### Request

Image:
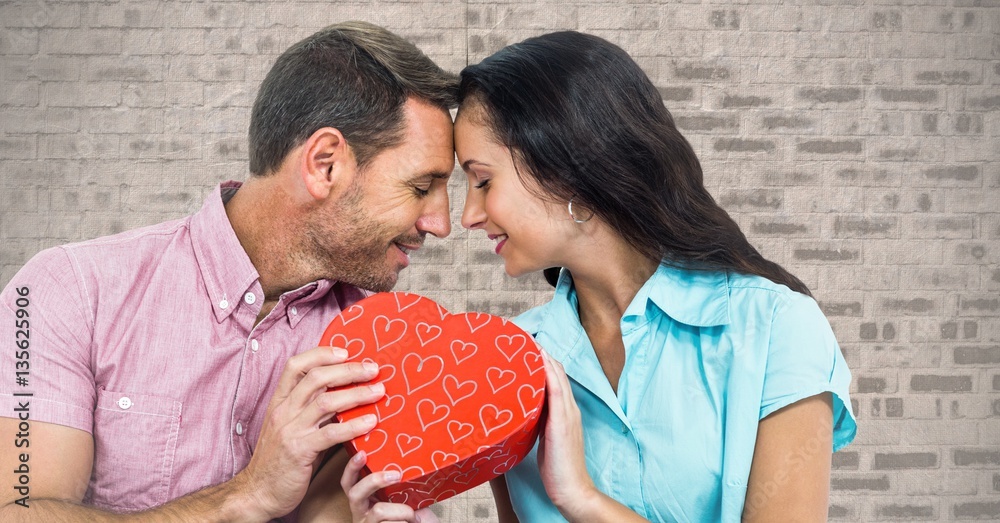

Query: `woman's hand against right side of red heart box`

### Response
(538, 352, 599, 519)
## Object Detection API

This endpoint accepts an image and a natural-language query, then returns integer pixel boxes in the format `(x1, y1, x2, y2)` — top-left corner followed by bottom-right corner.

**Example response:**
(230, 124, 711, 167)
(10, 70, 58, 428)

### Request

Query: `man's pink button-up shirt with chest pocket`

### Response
(0, 182, 368, 511)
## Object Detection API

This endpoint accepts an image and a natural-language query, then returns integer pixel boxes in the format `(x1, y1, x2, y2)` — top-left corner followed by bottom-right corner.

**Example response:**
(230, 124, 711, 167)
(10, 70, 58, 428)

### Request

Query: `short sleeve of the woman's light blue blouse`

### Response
(760, 293, 857, 452)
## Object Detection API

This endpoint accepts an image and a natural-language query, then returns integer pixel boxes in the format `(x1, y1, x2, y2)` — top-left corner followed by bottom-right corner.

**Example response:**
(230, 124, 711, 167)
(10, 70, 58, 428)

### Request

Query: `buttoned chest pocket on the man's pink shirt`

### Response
(85, 389, 181, 512)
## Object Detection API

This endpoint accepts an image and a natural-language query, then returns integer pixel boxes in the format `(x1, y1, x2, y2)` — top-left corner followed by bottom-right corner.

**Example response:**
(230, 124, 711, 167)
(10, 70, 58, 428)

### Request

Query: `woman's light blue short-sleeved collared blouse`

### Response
(506, 265, 857, 523)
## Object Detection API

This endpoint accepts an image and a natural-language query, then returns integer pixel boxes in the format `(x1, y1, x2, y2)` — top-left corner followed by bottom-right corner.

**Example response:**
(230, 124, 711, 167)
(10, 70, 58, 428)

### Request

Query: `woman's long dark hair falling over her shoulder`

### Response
(459, 31, 811, 295)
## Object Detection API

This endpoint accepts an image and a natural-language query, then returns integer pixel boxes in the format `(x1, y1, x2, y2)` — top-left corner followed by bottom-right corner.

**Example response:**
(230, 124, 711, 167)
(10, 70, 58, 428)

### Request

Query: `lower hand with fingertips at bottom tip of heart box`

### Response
(340, 451, 438, 523)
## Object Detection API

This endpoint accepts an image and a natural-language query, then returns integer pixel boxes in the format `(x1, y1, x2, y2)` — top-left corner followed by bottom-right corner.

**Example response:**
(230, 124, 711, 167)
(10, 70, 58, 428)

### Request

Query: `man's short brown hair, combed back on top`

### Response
(249, 22, 458, 176)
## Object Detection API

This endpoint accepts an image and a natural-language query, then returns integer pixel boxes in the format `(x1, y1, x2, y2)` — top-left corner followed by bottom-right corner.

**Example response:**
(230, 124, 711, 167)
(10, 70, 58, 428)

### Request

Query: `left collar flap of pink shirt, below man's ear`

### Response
(191, 181, 261, 322)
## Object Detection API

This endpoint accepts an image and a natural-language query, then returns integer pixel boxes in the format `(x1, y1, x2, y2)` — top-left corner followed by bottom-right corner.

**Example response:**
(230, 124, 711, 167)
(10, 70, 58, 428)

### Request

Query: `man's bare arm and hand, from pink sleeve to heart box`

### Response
(0, 347, 385, 523)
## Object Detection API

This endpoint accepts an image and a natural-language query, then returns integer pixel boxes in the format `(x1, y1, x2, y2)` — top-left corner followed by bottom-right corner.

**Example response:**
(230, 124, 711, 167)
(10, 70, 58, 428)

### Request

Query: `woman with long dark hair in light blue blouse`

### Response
(455, 32, 856, 522)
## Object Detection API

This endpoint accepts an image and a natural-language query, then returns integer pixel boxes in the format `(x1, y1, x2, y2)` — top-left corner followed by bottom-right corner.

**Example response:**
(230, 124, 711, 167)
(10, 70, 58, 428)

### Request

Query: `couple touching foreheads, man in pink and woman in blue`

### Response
(0, 23, 855, 522)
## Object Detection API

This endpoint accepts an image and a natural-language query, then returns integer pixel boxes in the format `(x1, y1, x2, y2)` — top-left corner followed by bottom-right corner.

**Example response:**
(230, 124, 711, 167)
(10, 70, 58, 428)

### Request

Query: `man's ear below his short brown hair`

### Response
(299, 127, 358, 200)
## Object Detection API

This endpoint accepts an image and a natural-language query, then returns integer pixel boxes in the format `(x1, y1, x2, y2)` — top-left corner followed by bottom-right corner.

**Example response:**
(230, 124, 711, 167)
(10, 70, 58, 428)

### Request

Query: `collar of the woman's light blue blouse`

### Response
(554, 264, 730, 327)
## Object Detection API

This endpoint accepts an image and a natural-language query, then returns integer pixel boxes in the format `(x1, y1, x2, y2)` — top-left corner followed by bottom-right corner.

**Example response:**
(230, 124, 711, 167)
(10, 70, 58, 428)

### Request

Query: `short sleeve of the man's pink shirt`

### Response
(0, 247, 97, 432)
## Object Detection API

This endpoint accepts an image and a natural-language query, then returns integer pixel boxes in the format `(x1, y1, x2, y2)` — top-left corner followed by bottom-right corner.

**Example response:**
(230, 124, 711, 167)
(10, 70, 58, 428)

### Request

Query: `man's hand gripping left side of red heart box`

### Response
(234, 347, 385, 519)
